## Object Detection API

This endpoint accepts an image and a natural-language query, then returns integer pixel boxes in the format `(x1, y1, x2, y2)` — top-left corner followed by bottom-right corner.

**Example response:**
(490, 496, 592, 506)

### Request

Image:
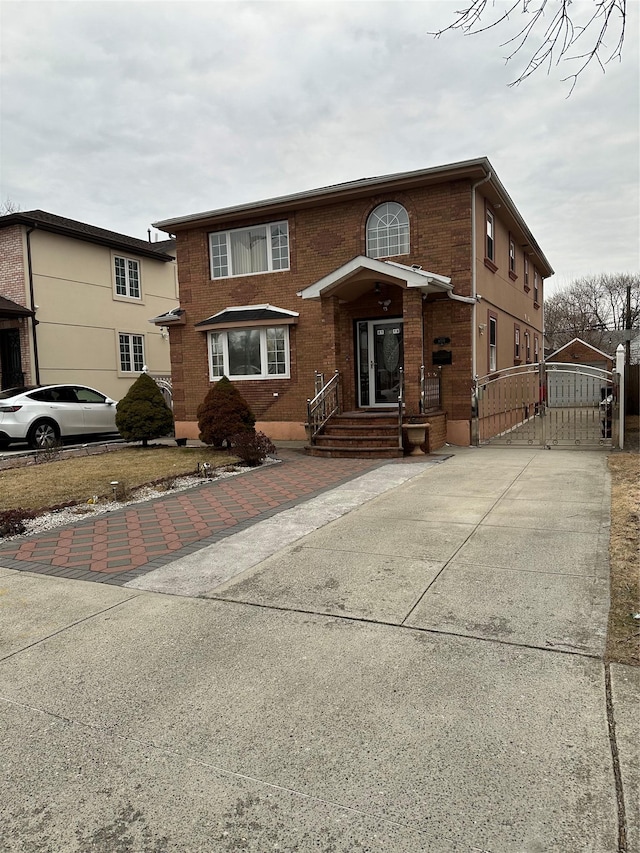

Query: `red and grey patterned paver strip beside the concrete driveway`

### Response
(0, 450, 383, 585)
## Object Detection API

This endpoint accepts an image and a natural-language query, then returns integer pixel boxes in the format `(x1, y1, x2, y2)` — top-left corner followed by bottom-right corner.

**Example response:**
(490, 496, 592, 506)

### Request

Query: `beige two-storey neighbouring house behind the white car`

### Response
(0, 210, 178, 400)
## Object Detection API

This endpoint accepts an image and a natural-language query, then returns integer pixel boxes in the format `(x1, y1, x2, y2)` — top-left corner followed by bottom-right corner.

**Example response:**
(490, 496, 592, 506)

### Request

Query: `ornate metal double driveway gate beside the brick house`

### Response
(472, 362, 618, 448)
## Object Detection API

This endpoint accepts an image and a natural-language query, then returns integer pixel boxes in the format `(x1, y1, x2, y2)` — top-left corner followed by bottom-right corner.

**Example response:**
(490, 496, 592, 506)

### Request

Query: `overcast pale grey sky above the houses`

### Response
(0, 0, 640, 292)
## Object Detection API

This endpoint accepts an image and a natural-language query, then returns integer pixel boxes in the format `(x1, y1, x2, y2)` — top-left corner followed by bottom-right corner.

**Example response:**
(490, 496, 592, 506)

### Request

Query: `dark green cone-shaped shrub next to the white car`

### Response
(116, 373, 173, 447)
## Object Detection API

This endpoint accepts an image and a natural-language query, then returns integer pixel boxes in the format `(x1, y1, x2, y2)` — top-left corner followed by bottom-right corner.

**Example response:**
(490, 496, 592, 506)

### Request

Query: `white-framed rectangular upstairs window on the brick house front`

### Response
(209, 222, 289, 278)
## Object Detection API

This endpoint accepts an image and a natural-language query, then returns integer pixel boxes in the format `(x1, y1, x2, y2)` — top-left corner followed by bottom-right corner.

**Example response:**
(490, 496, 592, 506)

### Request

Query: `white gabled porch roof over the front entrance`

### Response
(298, 255, 453, 302)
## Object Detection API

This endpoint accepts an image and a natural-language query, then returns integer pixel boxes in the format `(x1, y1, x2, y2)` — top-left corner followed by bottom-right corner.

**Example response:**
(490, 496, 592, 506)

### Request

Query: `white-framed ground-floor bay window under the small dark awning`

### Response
(207, 326, 290, 379)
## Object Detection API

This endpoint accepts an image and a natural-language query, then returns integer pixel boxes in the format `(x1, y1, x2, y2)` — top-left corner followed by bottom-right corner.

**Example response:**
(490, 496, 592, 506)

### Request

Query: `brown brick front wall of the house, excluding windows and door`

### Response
(170, 181, 471, 422)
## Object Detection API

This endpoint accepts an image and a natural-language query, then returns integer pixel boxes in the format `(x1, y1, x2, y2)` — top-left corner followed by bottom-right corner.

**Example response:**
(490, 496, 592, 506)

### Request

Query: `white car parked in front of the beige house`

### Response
(0, 385, 118, 449)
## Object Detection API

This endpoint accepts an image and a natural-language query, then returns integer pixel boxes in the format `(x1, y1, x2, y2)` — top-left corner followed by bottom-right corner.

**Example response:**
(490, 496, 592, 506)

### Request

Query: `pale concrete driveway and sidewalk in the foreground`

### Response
(0, 449, 640, 853)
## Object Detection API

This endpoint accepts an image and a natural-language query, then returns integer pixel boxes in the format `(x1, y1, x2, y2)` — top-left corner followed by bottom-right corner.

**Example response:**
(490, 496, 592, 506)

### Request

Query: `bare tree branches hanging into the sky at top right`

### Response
(431, 0, 627, 94)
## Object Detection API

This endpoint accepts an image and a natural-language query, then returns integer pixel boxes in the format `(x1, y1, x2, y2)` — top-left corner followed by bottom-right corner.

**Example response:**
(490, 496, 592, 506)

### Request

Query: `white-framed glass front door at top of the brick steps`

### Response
(357, 317, 404, 408)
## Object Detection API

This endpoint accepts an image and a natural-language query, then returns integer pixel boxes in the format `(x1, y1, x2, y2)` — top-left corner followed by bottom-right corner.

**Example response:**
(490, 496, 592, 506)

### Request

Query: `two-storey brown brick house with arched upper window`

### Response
(155, 158, 553, 456)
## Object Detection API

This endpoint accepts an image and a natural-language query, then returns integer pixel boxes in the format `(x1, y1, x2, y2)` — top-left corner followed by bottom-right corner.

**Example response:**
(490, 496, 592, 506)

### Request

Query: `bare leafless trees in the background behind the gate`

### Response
(544, 273, 640, 352)
